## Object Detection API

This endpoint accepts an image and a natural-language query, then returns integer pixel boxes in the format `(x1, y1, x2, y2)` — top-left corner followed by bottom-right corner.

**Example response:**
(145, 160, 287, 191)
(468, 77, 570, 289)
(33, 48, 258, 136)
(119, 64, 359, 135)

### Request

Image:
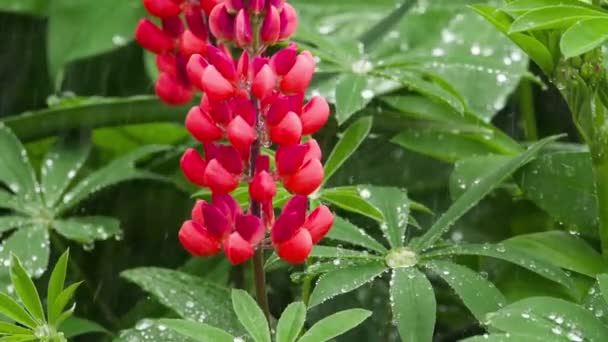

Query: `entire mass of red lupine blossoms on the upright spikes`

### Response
(135, 0, 334, 264)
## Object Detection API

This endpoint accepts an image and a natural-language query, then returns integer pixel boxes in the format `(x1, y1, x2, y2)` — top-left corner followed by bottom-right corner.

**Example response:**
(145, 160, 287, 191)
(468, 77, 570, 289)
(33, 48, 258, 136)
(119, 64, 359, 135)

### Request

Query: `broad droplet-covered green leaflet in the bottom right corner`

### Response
(486, 297, 608, 341)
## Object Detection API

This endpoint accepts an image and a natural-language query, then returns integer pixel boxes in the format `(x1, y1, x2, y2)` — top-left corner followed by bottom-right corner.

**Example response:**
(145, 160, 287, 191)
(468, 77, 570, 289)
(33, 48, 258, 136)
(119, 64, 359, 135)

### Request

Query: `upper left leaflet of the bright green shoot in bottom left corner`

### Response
(11, 254, 45, 322)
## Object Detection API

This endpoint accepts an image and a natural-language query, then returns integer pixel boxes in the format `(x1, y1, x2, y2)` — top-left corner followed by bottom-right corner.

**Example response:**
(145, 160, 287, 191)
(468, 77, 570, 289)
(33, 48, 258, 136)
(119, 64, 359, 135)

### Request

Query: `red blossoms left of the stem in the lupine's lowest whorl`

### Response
(179, 195, 264, 265)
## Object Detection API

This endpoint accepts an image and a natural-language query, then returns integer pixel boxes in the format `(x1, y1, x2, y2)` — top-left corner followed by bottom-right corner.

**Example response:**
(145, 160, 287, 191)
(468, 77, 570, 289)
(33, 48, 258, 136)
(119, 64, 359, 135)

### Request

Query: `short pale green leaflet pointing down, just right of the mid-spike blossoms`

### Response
(336, 73, 374, 125)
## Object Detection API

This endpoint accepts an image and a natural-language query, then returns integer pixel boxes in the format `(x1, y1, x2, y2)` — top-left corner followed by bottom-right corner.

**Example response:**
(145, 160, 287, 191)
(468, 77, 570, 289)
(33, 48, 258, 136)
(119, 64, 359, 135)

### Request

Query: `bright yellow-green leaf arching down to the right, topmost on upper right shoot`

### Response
(471, 4, 556, 75)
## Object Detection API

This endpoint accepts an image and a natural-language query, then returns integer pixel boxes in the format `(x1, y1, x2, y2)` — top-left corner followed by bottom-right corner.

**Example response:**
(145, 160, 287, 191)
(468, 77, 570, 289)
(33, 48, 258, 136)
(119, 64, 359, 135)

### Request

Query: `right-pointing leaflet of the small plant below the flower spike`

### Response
(298, 309, 372, 342)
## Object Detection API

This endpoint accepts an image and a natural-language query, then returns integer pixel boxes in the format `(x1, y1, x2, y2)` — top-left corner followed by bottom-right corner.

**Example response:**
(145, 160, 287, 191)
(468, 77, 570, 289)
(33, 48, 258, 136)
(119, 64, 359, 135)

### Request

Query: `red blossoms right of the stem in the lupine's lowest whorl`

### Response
(271, 196, 334, 264)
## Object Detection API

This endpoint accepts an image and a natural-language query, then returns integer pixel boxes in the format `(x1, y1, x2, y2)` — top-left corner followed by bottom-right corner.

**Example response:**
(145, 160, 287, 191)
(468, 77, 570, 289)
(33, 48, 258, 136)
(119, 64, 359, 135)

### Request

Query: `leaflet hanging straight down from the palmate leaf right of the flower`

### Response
(390, 267, 437, 342)
